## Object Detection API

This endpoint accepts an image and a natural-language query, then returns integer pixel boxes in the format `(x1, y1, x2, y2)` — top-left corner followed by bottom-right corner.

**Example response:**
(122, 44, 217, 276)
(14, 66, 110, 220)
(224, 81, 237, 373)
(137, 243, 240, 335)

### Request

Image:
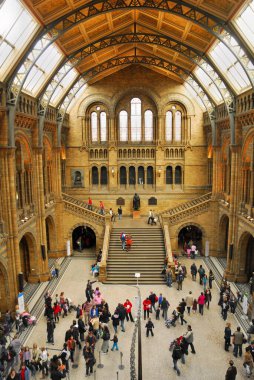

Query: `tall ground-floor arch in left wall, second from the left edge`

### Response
(19, 232, 38, 281)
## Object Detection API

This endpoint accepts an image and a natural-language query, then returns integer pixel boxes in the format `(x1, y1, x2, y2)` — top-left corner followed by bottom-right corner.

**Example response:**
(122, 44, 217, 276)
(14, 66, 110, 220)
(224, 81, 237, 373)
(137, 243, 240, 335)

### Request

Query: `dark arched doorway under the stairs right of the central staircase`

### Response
(178, 224, 202, 254)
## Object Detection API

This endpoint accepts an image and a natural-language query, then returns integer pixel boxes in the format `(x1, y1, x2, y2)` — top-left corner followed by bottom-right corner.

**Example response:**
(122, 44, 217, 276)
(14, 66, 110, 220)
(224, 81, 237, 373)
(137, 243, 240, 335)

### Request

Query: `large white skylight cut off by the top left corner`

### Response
(0, 0, 38, 80)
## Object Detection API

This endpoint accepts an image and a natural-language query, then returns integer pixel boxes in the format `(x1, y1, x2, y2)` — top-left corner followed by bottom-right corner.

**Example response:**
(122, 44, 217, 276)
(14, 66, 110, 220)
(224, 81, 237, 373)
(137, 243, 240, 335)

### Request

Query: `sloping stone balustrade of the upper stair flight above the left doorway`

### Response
(62, 193, 105, 224)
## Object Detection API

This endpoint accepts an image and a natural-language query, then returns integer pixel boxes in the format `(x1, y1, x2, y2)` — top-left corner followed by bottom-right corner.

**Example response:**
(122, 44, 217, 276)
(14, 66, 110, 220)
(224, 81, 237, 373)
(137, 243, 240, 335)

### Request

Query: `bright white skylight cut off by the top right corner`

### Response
(235, 1, 254, 50)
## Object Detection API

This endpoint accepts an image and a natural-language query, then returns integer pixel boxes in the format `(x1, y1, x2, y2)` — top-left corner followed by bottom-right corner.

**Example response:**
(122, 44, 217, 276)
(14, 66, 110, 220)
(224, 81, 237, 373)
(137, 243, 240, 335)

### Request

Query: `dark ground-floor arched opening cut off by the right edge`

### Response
(238, 231, 254, 277)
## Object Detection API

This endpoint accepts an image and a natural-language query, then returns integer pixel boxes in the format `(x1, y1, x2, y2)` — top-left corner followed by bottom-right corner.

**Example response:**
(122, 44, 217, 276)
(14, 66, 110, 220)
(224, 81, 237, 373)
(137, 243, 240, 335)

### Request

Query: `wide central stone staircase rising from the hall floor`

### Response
(106, 225, 165, 284)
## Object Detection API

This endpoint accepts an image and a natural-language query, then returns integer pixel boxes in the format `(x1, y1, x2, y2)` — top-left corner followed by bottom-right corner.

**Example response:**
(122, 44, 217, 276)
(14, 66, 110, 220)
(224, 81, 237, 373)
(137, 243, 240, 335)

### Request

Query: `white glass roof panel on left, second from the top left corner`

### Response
(23, 44, 63, 96)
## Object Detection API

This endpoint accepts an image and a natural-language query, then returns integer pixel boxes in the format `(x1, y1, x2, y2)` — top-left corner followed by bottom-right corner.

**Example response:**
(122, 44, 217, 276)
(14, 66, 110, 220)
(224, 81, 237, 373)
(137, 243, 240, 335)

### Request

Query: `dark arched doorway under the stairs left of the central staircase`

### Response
(72, 226, 96, 252)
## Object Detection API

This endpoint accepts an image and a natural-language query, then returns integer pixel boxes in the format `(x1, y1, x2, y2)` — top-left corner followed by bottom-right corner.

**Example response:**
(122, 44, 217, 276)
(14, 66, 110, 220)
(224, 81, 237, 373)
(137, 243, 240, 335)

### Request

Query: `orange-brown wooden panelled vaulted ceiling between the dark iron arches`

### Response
(25, 0, 244, 82)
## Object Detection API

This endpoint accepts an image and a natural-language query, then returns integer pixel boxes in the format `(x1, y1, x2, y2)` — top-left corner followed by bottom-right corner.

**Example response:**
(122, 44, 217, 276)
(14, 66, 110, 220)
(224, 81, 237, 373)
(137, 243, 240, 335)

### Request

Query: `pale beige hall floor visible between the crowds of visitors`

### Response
(26, 257, 245, 380)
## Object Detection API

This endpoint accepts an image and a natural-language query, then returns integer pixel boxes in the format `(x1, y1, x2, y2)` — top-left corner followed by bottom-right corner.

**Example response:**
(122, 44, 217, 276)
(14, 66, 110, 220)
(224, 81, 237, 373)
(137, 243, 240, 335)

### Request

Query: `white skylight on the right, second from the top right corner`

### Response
(209, 38, 250, 93)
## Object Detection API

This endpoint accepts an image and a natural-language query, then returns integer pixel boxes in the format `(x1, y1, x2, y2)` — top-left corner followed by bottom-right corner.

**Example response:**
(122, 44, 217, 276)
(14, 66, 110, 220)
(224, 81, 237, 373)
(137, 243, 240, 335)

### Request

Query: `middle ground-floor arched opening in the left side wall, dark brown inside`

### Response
(19, 234, 35, 281)
